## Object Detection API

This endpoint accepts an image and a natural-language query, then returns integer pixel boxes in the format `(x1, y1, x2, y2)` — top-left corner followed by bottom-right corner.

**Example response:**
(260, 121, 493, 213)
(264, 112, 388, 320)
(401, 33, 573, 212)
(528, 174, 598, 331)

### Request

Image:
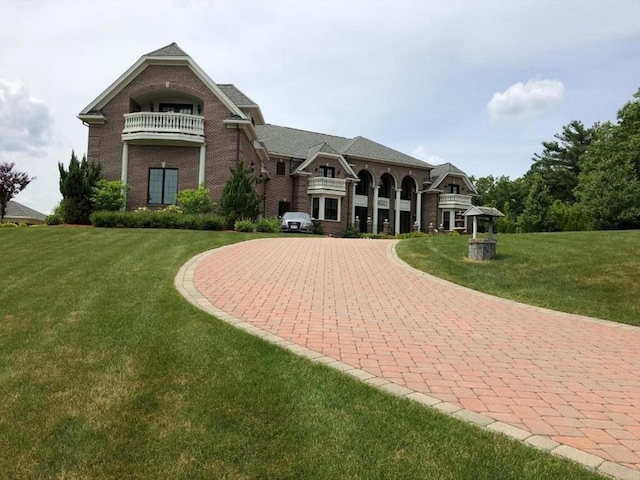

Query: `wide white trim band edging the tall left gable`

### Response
(80, 56, 247, 120)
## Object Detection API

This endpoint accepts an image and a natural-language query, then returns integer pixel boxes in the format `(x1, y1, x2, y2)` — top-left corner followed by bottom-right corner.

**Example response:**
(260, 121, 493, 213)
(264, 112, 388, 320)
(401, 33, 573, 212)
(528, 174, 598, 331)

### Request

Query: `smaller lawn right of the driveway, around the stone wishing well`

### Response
(397, 230, 640, 325)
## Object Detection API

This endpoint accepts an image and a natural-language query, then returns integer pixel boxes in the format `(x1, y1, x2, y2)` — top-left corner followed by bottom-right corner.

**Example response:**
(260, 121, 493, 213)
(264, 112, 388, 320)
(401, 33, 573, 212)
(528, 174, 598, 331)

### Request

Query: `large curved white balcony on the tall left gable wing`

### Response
(122, 112, 204, 145)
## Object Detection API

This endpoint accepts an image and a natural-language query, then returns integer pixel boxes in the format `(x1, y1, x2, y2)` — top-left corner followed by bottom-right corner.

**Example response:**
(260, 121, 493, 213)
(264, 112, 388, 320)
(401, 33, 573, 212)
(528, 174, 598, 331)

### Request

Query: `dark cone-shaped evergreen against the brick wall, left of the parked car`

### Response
(220, 160, 260, 225)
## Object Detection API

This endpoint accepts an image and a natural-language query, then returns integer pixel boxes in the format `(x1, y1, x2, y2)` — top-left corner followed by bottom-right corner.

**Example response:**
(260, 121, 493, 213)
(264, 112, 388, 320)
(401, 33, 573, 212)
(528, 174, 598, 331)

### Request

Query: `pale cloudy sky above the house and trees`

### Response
(0, 0, 640, 213)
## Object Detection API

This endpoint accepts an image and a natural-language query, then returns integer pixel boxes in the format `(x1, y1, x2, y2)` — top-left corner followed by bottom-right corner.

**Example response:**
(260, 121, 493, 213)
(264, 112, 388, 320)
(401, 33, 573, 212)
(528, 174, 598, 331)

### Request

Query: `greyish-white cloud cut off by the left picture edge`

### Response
(0, 79, 53, 153)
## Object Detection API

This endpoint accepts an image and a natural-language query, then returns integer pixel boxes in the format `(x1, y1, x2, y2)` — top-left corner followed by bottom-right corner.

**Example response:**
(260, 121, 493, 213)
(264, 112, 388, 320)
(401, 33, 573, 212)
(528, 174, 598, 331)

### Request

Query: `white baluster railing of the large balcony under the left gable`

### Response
(122, 112, 204, 137)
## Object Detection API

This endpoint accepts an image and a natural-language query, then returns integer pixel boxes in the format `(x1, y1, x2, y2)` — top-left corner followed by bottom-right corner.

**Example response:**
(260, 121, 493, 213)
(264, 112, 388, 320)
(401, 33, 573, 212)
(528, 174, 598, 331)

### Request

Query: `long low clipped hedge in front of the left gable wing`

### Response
(91, 209, 226, 230)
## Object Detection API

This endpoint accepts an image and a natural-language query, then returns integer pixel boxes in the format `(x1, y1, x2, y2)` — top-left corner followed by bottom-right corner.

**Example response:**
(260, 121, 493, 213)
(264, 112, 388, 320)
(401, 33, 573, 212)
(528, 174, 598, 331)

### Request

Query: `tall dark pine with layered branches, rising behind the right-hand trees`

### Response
(529, 120, 598, 204)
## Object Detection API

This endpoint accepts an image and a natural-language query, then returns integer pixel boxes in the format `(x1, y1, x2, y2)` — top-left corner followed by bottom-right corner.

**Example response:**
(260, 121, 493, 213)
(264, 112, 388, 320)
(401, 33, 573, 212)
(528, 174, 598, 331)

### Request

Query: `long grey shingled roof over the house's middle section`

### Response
(256, 124, 432, 168)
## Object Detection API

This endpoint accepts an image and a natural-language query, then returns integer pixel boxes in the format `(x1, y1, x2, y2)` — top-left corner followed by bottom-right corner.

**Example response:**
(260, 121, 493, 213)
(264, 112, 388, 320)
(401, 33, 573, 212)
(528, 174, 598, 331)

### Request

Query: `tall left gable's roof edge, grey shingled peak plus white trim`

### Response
(78, 43, 247, 123)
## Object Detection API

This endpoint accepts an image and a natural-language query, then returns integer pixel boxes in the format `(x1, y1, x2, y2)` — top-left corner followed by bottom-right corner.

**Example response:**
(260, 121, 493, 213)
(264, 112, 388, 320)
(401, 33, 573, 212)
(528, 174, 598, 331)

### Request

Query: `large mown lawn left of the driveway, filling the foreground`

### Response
(0, 227, 602, 480)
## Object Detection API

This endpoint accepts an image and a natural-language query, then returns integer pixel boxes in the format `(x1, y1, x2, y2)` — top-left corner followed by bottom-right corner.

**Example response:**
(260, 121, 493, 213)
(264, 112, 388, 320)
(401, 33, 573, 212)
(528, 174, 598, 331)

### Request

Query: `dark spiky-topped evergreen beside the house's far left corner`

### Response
(58, 151, 101, 225)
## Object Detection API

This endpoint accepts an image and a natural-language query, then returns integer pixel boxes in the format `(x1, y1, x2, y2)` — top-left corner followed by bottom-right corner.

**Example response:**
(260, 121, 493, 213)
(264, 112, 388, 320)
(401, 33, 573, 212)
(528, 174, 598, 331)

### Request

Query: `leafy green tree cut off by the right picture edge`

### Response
(576, 89, 640, 229)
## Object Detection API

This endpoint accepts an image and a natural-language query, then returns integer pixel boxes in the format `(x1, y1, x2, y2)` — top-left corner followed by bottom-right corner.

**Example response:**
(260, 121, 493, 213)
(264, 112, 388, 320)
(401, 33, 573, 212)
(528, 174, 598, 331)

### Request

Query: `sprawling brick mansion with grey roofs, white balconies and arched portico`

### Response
(78, 43, 476, 235)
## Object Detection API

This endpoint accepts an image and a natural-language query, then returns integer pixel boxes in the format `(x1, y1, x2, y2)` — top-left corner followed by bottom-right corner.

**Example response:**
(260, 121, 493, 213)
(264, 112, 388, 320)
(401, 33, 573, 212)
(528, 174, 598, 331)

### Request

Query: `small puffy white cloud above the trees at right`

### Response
(487, 79, 564, 119)
